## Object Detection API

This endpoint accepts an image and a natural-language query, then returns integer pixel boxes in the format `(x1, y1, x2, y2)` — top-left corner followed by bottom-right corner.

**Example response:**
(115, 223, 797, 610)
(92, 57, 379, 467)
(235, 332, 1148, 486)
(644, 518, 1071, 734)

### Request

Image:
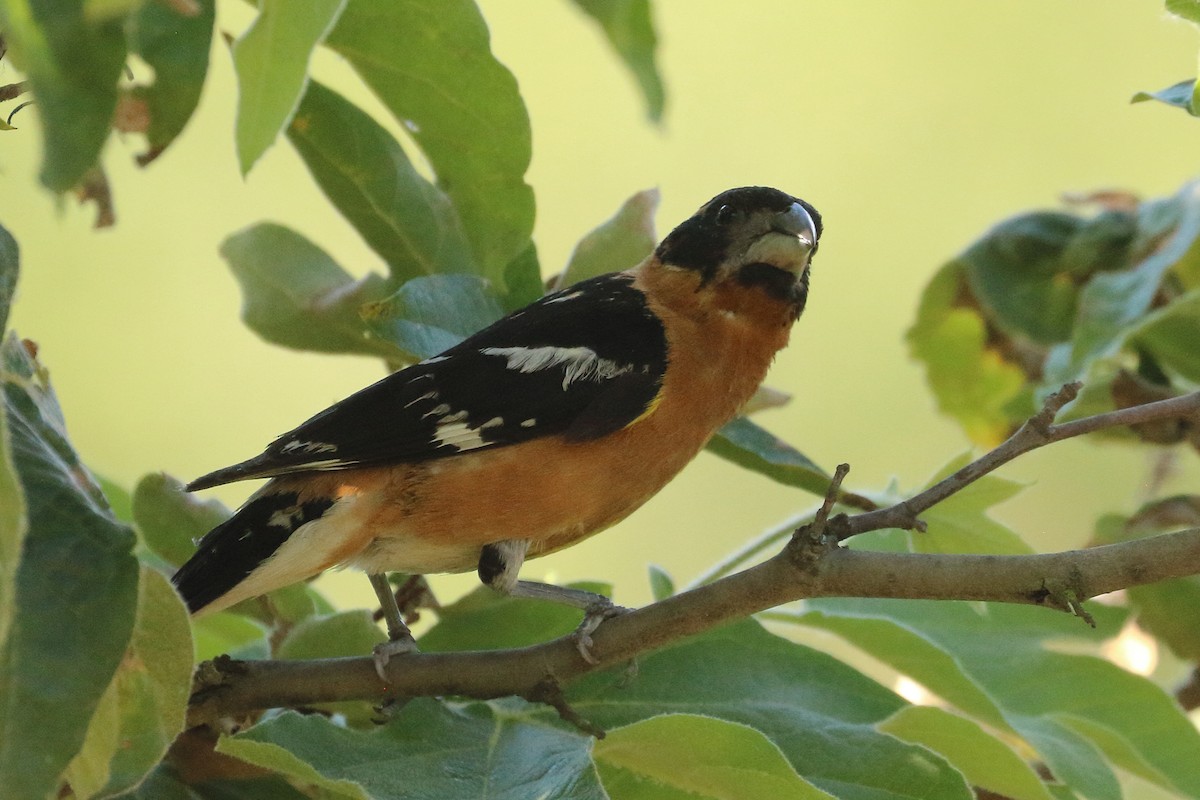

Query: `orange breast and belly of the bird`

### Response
(338, 266, 791, 571)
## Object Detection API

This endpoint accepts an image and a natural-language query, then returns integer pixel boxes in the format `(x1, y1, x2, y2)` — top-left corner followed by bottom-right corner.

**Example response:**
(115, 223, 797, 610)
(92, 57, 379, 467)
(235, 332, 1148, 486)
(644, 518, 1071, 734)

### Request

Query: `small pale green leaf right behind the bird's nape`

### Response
(554, 188, 659, 289)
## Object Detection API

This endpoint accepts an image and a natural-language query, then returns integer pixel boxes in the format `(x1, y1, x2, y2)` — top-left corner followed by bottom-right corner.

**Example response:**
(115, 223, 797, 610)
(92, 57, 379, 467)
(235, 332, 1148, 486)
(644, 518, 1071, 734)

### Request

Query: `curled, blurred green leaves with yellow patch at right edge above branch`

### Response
(908, 184, 1200, 446)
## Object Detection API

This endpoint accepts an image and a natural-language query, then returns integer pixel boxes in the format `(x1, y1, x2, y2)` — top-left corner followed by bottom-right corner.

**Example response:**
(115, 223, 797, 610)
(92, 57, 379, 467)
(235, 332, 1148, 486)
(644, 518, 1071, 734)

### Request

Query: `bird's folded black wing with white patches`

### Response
(188, 272, 667, 489)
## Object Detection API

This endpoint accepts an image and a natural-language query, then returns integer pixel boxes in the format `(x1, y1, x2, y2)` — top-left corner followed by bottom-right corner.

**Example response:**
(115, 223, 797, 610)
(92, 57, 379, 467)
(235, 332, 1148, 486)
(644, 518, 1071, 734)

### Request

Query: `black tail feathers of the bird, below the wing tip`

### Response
(170, 491, 334, 614)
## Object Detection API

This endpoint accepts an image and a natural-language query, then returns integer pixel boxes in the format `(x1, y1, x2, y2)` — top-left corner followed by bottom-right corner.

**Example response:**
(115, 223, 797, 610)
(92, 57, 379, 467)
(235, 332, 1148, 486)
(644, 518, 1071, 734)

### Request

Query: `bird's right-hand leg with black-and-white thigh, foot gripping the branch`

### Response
(479, 539, 629, 664)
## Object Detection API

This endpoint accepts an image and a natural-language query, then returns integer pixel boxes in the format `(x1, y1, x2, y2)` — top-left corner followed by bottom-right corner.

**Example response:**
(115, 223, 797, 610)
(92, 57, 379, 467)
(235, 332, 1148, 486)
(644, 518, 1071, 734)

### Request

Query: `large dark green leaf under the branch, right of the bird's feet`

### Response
(564, 620, 972, 800)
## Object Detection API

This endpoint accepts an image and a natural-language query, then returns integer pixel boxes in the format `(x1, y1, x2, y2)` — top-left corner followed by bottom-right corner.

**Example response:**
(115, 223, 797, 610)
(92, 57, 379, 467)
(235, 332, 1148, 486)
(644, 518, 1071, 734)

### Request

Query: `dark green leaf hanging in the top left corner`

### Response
(0, 0, 125, 192)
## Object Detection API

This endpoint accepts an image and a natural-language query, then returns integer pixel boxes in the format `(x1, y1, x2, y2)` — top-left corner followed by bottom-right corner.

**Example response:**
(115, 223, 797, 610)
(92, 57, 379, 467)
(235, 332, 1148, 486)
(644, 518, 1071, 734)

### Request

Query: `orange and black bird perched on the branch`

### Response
(172, 186, 822, 662)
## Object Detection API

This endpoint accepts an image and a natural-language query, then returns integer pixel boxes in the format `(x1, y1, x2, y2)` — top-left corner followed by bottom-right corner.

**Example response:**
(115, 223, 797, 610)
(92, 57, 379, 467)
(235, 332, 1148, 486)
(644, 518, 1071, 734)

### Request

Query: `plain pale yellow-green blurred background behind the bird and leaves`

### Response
(0, 0, 1200, 642)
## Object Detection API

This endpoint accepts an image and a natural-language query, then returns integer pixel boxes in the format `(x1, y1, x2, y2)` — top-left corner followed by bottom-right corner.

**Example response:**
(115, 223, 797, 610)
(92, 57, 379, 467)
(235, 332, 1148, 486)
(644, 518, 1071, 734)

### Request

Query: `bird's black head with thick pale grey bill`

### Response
(652, 186, 821, 324)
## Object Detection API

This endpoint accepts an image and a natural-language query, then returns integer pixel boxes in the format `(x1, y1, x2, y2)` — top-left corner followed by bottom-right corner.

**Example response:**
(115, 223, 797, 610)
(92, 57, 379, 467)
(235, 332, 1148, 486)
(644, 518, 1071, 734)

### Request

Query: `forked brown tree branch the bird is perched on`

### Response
(188, 385, 1200, 724)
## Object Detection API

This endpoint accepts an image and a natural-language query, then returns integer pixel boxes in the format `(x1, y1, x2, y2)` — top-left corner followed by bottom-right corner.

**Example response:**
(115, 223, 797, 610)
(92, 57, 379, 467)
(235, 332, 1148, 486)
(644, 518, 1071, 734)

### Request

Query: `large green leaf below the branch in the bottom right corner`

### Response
(798, 599, 1200, 798)
